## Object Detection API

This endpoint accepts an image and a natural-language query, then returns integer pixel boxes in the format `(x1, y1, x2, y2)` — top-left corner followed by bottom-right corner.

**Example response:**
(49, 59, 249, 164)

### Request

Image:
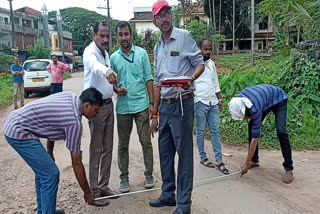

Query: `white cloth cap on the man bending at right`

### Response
(228, 97, 252, 120)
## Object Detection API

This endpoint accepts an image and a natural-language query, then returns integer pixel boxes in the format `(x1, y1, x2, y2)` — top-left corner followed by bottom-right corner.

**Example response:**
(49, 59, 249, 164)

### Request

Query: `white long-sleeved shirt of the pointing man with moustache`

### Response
(83, 41, 113, 99)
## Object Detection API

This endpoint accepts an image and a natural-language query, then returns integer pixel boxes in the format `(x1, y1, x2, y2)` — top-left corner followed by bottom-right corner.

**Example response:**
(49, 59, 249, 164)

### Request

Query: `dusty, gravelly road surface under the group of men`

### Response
(0, 73, 320, 214)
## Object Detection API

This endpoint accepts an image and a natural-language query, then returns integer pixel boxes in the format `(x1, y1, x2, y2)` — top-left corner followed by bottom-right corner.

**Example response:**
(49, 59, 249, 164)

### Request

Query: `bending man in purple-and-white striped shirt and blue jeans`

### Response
(3, 88, 107, 214)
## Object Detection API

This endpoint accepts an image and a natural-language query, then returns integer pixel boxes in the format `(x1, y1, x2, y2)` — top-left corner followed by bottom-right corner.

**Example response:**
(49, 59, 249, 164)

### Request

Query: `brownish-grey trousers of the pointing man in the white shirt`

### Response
(89, 102, 114, 193)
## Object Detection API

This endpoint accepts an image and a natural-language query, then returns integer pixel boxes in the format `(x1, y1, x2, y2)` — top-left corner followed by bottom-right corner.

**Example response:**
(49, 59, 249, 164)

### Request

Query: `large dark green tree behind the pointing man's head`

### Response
(49, 7, 117, 54)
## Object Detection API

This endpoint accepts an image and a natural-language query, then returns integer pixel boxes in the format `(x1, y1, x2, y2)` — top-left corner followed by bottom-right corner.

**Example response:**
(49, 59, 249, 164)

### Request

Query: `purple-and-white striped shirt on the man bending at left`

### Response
(3, 92, 82, 154)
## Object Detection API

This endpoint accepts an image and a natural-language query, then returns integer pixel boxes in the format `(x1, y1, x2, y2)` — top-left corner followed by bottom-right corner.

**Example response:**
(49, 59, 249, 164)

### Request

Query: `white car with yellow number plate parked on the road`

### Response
(23, 59, 51, 98)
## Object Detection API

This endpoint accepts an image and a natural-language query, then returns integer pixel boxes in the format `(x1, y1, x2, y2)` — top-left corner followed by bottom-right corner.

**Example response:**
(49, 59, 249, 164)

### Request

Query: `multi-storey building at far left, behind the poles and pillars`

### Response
(0, 7, 74, 63)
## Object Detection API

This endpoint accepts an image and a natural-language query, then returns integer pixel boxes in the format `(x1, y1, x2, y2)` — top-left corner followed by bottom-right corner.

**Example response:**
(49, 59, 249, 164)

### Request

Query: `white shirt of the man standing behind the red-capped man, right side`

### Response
(194, 59, 220, 105)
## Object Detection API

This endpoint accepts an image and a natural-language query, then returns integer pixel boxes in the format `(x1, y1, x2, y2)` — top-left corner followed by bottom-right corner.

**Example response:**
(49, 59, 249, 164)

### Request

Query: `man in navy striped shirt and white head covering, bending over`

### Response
(228, 84, 293, 184)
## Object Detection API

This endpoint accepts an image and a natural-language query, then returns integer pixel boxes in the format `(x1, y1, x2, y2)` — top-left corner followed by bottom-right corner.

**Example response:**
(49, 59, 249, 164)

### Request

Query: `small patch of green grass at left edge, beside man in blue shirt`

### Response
(0, 75, 13, 107)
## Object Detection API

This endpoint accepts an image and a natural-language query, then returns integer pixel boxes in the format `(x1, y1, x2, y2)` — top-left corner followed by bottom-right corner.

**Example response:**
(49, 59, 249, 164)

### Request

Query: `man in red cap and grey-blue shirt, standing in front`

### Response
(149, 0, 204, 214)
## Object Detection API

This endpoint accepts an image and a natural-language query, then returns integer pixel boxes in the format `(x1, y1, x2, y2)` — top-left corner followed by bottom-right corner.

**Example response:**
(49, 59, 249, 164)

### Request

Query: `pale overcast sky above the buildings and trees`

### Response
(0, 0, 177, 21)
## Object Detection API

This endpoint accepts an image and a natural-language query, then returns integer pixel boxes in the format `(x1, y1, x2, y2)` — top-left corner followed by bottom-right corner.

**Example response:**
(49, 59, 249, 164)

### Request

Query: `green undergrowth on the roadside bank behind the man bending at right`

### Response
(216, 54, 320, 150)
